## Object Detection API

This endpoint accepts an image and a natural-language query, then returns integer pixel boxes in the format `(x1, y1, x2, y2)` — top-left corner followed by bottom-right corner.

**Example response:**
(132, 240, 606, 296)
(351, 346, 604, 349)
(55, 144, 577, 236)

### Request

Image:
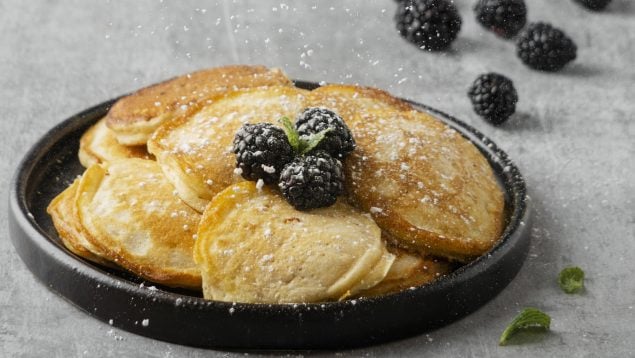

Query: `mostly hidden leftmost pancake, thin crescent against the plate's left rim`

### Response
(46, 179, 110, 266)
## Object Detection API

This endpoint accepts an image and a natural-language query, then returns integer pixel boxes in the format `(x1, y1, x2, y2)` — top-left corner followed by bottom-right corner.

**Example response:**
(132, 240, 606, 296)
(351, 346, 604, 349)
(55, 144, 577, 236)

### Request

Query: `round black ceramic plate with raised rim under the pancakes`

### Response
(9, 81, 530, 349)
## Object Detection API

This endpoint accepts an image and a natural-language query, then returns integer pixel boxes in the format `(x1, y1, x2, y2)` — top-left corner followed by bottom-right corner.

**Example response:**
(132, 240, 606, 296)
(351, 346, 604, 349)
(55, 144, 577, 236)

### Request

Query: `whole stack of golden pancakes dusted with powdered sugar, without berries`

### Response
(48, 66, 504, 303)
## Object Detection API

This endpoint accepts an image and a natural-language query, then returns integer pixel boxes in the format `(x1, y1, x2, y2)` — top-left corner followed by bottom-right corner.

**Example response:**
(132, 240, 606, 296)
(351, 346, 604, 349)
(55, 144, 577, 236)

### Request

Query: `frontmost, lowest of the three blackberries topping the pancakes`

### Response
(278, 150, 344, 210)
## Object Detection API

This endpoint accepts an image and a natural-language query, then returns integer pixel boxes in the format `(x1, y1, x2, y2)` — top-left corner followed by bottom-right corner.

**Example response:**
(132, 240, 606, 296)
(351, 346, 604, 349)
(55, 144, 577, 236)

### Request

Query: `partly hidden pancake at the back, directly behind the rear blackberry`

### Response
(305, 84, 412, 122)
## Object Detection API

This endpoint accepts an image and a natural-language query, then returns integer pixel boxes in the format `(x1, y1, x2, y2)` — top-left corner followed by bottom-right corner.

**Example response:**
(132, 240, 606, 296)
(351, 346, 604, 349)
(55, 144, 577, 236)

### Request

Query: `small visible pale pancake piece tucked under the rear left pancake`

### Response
(78, 118, 151, 168)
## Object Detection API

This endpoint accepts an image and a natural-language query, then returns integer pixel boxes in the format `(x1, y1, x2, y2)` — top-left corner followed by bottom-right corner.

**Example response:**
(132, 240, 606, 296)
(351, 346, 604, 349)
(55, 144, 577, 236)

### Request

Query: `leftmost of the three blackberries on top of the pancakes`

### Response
(233, 123, 293, 184)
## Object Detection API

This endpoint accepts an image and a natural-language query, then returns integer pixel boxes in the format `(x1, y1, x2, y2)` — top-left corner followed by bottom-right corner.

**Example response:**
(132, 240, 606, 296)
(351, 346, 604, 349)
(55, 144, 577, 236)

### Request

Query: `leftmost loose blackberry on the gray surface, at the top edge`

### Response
(395, 0, 462, 51)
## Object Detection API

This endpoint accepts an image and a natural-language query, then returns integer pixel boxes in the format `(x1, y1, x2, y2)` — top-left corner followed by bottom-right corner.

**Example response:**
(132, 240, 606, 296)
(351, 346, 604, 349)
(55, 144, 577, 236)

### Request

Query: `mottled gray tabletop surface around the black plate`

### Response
(0, 0, 635, 357)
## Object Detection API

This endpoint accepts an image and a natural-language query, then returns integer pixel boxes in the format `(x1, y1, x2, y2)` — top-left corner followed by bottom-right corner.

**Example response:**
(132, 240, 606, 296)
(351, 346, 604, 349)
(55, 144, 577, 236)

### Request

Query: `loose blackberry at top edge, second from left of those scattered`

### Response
(474, 0, 527, 38)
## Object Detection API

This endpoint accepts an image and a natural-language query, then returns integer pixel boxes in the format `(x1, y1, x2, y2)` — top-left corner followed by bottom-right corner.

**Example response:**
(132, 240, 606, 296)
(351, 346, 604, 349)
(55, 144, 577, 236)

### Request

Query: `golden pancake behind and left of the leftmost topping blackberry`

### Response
(148, 86, 307, 212)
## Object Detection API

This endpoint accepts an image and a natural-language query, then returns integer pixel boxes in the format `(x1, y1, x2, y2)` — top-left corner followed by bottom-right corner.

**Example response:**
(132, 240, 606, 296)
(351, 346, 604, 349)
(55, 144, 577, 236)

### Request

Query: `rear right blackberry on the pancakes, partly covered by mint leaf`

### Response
(295, 107, 355, 159)
